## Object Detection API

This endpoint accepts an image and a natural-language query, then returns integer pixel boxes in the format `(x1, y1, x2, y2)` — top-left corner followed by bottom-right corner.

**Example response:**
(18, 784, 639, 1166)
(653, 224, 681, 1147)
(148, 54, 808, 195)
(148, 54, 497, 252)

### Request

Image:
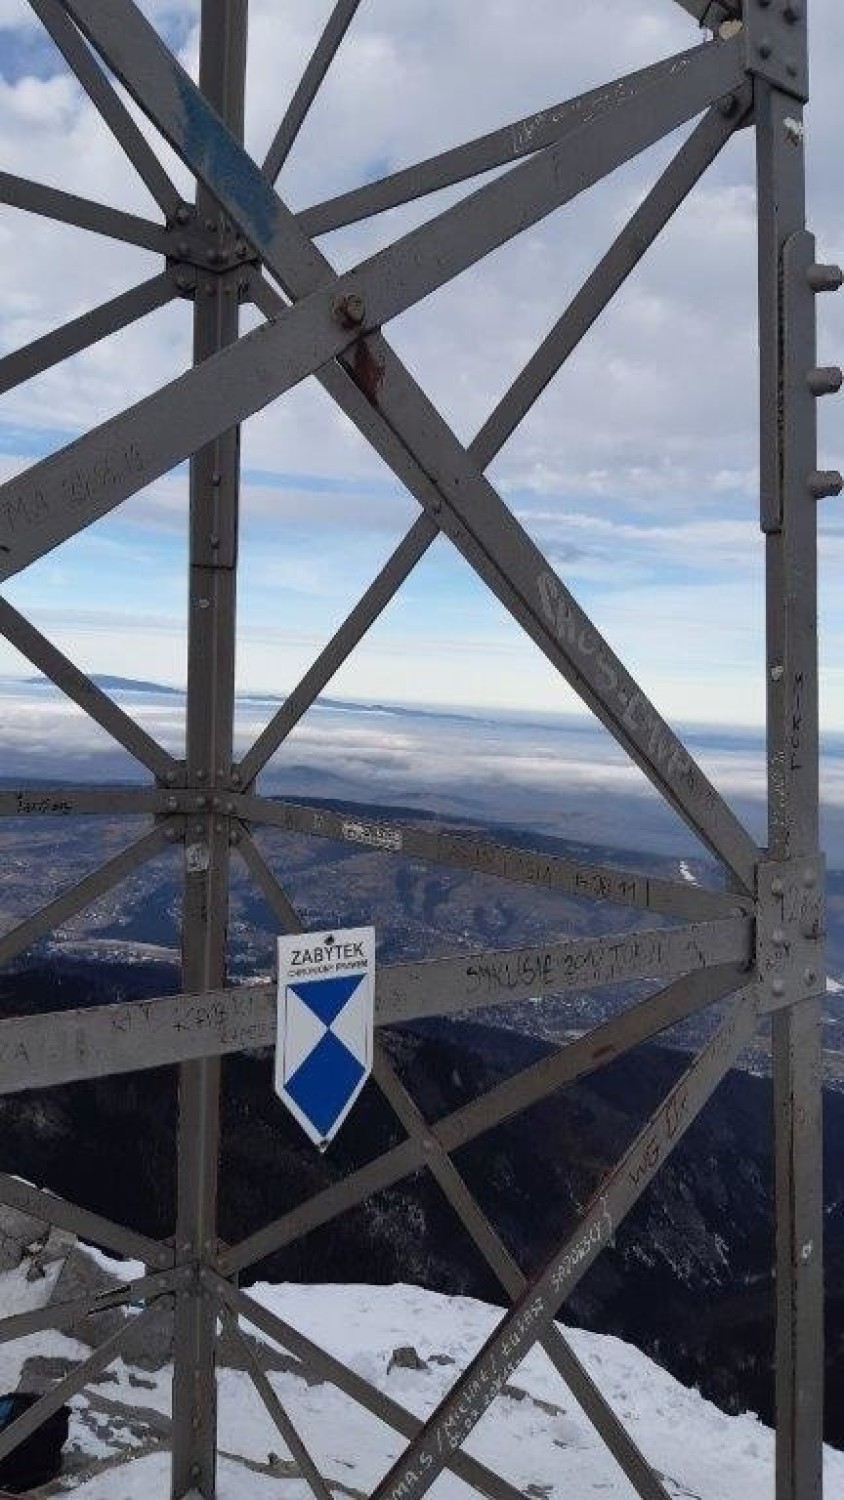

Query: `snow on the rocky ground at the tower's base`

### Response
(0, 1272, 844, 1500)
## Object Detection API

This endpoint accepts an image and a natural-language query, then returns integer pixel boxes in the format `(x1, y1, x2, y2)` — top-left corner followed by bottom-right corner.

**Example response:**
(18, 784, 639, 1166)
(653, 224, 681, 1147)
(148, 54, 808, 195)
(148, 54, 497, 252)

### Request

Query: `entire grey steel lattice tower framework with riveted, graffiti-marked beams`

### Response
(0, 0, 843, 1500)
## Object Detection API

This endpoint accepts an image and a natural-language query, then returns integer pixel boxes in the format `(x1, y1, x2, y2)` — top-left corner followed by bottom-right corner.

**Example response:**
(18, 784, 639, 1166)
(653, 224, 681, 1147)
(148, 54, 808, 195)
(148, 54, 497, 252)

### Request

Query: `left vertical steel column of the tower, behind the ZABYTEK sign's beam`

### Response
(172, 0, 247, 1500)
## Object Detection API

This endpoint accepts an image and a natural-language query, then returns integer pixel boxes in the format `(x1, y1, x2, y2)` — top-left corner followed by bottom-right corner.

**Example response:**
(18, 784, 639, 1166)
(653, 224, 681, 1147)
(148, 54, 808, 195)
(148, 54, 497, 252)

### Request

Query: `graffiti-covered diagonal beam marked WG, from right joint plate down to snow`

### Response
(372, 995, 756, 1500)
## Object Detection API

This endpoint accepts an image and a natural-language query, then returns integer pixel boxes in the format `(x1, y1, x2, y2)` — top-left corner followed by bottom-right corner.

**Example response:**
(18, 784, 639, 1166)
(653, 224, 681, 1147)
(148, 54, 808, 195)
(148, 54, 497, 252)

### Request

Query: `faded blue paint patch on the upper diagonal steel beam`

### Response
(175, 71, 280, 249)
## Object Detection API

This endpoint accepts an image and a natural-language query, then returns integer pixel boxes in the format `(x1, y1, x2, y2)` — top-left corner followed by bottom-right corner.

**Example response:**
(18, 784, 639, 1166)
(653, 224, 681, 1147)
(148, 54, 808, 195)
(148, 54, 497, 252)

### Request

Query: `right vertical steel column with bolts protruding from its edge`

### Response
(756, 26, 823, 1500)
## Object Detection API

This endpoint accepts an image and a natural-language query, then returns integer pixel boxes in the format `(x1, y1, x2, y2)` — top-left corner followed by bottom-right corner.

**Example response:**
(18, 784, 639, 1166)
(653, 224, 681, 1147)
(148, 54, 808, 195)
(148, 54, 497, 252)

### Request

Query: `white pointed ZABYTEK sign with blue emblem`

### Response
(276, 927, 375, 1149)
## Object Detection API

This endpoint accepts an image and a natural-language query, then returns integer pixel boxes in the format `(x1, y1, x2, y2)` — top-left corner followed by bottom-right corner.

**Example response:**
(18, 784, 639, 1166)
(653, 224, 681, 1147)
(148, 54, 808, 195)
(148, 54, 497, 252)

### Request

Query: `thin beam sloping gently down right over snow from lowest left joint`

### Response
(211, 1271, 525, 1500)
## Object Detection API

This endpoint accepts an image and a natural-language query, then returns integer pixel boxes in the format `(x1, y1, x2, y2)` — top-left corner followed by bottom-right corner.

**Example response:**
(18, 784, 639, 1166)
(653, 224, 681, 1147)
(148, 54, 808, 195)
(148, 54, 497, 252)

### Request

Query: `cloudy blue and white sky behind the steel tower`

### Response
(0, 0, 844, 731)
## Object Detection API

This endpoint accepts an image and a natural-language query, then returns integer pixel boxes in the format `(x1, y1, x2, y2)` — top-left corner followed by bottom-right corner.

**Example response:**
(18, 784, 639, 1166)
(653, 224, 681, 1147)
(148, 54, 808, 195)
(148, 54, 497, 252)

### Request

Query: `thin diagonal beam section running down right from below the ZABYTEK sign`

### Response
(373, 1047, 669, 1500)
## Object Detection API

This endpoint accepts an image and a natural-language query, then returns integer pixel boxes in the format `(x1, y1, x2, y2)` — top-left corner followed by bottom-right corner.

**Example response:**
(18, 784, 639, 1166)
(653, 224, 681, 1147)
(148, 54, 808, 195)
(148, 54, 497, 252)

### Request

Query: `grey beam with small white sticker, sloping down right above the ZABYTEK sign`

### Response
(232, 792, 750, 921)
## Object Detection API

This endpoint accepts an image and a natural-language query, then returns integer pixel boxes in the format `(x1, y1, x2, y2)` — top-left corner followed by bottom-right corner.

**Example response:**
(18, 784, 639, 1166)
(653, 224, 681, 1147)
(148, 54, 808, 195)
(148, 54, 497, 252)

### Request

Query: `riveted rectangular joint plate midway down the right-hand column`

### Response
(756, 855, 826, 1014)
